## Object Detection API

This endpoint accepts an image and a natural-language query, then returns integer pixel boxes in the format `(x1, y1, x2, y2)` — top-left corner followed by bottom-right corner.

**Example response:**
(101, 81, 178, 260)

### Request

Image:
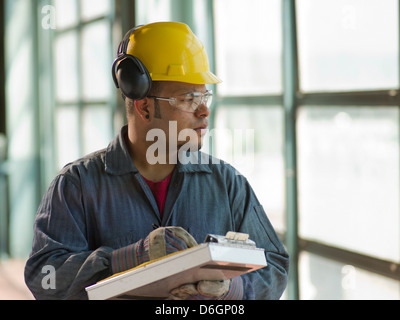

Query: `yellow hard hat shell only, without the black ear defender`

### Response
(126, 22, 221, 84)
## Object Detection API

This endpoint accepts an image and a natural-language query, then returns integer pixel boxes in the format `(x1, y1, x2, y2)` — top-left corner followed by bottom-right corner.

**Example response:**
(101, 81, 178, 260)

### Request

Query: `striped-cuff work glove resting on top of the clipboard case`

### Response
(111, 227, 197, 273)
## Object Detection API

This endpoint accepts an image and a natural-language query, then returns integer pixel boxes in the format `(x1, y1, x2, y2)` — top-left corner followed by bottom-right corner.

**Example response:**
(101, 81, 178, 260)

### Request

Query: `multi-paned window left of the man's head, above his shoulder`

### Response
(54, 0, 114, 169)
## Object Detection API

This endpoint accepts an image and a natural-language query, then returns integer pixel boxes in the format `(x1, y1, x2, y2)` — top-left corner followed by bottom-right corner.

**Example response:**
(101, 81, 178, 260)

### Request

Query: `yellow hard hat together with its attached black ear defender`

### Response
(112, 22, 221, 100)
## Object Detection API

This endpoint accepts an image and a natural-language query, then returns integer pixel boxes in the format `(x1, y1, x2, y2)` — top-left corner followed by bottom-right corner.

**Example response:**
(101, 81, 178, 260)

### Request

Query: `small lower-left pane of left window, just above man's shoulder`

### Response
(55, 106, 81, 170)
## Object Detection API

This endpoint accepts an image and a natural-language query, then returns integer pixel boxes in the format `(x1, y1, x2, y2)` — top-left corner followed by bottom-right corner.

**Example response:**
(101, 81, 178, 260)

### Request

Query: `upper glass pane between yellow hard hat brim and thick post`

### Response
(214, 0, 282, 95)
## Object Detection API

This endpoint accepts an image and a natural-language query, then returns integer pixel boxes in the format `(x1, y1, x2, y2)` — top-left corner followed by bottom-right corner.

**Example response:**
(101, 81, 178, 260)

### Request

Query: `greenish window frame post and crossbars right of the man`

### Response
(210, 0, 400, 300)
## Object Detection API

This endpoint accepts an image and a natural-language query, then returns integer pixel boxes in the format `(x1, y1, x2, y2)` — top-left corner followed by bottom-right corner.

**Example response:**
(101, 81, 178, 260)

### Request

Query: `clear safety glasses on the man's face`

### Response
(148, 90, 213, 112)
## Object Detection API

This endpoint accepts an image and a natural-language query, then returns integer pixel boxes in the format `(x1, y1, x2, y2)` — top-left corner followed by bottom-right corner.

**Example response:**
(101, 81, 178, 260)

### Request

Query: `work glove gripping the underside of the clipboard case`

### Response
(169, 276, 243, 300)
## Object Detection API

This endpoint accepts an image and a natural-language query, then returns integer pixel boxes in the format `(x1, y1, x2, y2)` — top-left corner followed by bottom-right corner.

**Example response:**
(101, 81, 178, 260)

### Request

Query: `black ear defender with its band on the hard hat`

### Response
(111, 26, 152, 100)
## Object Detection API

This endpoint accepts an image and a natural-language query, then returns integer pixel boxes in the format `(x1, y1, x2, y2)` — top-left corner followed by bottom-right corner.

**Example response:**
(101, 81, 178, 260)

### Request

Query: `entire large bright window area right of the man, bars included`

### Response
(214, 0, 400, 299)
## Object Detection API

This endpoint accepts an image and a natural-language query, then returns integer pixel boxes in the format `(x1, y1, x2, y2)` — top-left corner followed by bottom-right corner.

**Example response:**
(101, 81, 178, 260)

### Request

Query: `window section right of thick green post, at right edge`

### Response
(295, 0, 400, 299)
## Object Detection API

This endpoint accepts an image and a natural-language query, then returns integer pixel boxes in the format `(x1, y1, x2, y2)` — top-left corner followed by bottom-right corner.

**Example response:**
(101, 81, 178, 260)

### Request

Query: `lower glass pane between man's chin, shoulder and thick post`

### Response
(211, 105, 286, 231)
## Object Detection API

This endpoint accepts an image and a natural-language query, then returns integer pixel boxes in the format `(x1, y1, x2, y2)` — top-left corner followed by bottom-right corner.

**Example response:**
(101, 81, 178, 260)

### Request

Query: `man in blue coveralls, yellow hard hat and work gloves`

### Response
(25, 22, 288, 299)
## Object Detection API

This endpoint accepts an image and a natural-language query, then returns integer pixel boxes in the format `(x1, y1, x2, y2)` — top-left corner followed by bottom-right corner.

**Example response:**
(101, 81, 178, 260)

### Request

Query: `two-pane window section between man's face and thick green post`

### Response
(214, 0, 285, 232)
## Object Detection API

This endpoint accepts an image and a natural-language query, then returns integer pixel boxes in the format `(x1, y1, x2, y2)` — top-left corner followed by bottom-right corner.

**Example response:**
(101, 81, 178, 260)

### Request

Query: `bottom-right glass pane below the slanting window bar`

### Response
(299, 252, 400, 300)
